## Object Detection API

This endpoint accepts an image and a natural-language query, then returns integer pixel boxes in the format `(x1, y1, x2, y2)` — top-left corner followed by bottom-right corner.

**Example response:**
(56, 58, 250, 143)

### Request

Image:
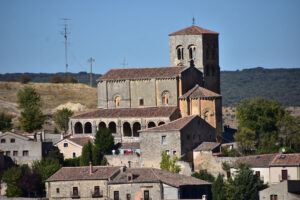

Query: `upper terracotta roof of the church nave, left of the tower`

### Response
(97, 66, 187, 81)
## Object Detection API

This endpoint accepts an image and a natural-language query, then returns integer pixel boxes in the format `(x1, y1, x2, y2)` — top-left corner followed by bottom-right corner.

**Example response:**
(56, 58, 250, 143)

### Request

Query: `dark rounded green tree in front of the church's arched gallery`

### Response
(95, 128, 114, 155)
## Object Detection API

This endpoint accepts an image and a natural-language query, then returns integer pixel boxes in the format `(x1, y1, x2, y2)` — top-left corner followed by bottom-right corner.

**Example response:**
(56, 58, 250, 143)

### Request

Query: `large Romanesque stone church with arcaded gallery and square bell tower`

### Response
(69, 25, 222, 147)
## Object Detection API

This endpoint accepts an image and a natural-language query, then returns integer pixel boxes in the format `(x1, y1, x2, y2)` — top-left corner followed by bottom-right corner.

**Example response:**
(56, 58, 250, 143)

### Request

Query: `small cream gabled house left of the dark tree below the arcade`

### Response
(54, 136, 94, 159)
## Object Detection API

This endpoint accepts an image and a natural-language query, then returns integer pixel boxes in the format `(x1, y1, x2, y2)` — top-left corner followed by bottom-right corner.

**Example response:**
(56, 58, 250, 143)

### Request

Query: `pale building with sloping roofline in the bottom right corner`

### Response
(259, 180, 300, 200)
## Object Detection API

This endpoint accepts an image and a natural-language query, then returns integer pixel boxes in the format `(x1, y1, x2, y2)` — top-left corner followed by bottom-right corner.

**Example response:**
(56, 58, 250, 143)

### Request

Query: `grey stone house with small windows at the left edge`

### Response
(0, 130, 52, 165)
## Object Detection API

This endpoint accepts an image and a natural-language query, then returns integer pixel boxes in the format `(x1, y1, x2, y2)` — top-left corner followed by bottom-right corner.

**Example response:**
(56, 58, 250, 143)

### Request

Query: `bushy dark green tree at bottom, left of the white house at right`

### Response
(227, 165, 267, 200)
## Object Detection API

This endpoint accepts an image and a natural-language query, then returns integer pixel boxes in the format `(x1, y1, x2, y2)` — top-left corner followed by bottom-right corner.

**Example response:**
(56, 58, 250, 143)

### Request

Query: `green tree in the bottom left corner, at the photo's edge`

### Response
(2, 167, 22, 197)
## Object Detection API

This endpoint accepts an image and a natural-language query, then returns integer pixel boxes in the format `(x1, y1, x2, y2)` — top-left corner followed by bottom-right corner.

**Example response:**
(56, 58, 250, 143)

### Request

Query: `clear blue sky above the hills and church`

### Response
(0, 0, 300, 73)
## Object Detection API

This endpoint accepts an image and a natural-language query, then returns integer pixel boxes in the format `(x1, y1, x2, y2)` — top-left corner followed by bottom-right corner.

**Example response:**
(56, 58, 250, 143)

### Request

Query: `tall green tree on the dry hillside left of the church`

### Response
(17, 87, 46, 132)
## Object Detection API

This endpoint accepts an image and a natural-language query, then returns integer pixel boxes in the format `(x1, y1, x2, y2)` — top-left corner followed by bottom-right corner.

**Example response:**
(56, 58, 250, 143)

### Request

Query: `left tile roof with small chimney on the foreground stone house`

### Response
(46, 166, 121, 181)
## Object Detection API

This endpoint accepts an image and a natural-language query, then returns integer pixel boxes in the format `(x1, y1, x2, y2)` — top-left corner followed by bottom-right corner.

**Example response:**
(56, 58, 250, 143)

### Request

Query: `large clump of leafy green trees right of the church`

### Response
(234, 98, 300, 155)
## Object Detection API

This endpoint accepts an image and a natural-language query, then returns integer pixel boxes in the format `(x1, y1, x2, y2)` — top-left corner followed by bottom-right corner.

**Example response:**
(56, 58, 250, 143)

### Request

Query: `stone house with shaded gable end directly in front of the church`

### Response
(140, 115, 216, 168)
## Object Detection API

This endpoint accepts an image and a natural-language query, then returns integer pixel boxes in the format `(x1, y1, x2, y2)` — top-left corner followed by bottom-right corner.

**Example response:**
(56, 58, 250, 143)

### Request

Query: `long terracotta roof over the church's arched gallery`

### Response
(71, 106, 178, 119)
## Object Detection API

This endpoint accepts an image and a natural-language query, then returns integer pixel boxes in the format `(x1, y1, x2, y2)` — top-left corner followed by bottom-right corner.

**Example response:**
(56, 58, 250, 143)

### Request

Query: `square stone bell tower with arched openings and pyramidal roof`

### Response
(169, 25, 220, 94)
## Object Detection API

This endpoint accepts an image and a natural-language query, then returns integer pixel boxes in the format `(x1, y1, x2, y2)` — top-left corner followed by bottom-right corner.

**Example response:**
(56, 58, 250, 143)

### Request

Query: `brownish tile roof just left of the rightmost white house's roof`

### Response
(232, 154, 277, 168)
